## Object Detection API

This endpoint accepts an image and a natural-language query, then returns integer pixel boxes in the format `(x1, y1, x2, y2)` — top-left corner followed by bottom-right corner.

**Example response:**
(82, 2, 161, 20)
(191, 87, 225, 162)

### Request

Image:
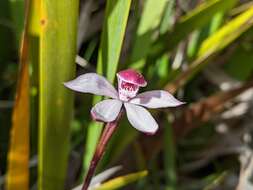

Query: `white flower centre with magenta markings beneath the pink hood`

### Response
(118, 79, 139, 101)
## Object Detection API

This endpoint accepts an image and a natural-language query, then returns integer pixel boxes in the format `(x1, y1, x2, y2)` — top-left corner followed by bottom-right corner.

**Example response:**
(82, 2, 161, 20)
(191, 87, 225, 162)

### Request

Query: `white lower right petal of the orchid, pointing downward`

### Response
(124, 103, 158, 134)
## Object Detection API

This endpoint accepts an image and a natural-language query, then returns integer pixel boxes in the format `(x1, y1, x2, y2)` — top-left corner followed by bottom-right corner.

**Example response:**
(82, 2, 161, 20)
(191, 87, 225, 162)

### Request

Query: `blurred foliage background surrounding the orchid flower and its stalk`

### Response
(0, 0, 253, 190)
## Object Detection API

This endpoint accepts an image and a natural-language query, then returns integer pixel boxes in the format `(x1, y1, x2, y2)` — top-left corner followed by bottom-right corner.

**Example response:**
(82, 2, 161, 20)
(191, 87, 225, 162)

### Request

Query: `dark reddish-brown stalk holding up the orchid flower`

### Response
(82, 110, 123, 190)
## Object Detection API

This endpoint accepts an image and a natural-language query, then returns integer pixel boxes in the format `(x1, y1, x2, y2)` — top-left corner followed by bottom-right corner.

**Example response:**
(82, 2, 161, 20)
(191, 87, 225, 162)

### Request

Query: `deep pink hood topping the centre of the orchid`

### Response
(117, 69, 147, 87)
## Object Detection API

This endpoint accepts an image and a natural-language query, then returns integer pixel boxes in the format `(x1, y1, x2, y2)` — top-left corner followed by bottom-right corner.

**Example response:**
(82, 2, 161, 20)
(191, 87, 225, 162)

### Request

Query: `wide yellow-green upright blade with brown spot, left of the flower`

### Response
(38, 0, 79, 190)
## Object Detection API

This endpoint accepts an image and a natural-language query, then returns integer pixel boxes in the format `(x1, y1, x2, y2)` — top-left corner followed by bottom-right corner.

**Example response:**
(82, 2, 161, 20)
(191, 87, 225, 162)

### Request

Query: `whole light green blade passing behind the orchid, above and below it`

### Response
(83, 0, 131, 178)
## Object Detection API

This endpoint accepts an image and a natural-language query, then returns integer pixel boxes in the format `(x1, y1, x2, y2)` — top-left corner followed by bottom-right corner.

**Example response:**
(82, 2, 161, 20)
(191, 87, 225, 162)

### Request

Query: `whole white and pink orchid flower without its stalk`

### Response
(64, 69, 183, 134)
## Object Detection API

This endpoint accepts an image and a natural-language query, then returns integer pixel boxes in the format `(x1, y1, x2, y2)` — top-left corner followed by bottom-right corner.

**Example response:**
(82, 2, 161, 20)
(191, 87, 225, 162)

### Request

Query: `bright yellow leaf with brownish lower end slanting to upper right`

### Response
(165, 6, 253, 93)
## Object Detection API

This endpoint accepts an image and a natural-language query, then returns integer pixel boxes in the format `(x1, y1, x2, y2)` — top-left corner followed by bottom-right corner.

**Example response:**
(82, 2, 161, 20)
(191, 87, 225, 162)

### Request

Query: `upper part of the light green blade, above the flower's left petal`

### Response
(98, 0, 131, 83)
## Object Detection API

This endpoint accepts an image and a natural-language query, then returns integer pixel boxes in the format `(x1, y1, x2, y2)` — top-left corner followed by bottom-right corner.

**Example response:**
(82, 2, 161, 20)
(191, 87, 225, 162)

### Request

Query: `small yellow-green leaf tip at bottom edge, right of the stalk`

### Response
(95, 170, 148, 190)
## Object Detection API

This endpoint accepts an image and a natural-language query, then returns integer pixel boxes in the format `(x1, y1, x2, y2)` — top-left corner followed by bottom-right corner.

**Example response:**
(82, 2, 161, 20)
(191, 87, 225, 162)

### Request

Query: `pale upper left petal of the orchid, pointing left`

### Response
(64, 73, 118, 99)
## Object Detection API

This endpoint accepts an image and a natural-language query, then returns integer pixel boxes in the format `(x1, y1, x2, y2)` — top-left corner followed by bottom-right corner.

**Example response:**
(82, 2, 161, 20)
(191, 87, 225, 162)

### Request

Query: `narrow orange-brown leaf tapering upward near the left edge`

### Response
(6, 2, 30, 190)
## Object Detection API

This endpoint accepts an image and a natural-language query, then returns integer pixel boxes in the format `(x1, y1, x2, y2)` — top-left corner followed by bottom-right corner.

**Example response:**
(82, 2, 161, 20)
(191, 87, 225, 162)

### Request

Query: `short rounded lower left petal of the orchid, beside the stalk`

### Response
(91, 99, 122, 122)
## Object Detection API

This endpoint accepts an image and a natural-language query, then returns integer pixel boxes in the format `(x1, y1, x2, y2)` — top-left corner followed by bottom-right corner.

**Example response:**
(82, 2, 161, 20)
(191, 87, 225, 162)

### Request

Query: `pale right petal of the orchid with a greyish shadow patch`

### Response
(130, 90, 184, 108)
